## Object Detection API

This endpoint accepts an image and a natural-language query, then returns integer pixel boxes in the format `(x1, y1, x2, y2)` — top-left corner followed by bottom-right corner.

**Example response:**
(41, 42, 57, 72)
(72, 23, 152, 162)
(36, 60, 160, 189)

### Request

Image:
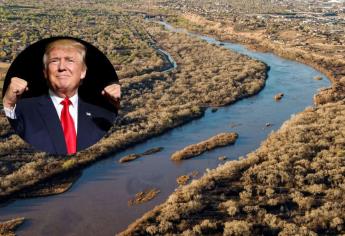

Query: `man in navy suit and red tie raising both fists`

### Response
(3, 39, 121, 155)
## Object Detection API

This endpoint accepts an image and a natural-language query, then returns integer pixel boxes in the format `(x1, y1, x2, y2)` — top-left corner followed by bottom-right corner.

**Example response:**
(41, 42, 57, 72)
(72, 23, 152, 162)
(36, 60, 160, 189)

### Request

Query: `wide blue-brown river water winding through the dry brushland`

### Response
(0, 21, 330, 236)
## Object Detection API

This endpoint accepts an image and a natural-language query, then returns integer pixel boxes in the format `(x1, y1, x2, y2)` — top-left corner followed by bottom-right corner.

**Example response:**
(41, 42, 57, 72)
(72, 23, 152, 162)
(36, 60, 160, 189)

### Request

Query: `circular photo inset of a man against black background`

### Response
(2, 37, 121, 155)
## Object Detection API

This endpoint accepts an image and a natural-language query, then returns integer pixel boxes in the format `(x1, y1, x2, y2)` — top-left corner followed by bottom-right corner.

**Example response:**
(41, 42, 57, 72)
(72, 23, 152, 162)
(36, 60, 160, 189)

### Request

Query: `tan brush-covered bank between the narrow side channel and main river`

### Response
(0, 19, 267, 201)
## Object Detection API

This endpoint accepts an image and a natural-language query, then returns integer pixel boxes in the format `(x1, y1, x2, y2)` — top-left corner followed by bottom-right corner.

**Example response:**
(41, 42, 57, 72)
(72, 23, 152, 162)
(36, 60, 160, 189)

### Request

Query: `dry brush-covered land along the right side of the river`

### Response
(119, 1, 345, 235)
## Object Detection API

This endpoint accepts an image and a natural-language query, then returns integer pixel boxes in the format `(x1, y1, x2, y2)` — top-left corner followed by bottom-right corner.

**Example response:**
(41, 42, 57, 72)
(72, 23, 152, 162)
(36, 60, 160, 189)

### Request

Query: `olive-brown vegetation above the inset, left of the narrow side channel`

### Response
(0, 1, 164, 78)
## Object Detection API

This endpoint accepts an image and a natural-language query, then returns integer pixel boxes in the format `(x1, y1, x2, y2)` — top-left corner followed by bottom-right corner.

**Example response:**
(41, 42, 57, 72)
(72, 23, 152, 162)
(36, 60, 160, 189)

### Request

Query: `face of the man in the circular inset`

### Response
(44, 47, 86, 97)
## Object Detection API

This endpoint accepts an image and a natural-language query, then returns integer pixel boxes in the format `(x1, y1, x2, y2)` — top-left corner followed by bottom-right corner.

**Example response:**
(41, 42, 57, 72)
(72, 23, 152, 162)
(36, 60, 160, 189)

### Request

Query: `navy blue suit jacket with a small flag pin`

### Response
(10, 95, 116, 155)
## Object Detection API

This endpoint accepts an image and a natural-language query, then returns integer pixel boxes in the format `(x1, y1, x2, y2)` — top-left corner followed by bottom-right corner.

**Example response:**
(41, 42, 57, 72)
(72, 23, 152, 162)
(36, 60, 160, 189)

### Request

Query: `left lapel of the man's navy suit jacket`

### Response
(38, 95, 67, 154)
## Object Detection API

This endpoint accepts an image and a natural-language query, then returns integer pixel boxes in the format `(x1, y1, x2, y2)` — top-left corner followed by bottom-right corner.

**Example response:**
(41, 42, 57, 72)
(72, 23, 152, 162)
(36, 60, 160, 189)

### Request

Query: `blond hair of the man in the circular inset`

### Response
(43, 39, 86, 68)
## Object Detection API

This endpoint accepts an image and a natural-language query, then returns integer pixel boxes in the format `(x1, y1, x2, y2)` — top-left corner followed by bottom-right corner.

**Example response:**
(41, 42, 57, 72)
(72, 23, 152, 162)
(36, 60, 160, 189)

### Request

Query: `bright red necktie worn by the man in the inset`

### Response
(61, 97, 77, 154)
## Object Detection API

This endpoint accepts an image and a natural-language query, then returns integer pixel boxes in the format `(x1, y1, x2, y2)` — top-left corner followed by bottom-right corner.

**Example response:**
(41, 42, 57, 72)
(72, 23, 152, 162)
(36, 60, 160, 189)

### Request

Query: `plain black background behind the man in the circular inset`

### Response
(2, 36, 119, 113)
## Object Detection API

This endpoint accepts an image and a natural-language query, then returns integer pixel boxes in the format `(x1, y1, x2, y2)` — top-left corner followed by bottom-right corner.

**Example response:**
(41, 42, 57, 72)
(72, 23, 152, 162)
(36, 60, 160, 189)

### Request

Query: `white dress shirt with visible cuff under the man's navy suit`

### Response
(4, 89, 78, 132)
